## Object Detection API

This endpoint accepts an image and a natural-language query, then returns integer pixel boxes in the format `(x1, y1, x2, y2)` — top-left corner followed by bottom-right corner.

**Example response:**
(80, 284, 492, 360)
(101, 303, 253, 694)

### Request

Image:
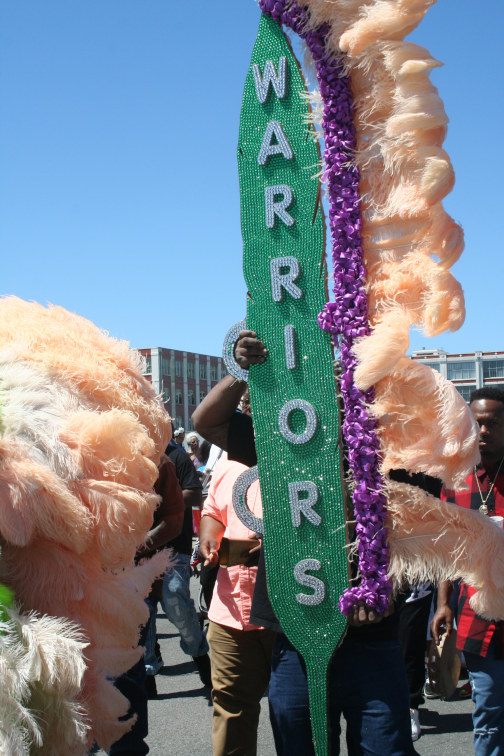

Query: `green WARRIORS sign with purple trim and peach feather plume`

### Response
(224, 0, 504, 753)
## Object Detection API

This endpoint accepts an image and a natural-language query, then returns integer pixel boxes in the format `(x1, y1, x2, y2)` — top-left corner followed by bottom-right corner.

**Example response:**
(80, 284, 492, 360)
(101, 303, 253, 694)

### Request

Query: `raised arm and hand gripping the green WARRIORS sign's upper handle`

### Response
(191, 331, 267, 450)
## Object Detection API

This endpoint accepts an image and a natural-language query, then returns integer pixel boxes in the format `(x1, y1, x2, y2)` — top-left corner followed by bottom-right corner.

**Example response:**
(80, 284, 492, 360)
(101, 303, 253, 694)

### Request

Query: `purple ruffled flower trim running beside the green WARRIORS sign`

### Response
(259, 0, 392, 615)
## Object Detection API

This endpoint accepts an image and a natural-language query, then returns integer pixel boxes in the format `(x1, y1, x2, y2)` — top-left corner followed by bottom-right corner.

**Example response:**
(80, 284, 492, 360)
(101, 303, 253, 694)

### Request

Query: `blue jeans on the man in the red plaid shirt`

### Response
(464, 636, 504, 756)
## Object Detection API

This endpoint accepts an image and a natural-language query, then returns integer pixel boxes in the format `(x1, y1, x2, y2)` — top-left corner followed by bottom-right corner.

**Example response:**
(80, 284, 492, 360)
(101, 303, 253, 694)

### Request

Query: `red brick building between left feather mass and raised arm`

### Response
(138, 347, 227, 431)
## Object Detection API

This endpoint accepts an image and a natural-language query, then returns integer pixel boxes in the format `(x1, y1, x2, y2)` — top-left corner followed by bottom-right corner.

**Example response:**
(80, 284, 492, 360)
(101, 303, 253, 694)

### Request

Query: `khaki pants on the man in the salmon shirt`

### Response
(208, 622, 275, 756)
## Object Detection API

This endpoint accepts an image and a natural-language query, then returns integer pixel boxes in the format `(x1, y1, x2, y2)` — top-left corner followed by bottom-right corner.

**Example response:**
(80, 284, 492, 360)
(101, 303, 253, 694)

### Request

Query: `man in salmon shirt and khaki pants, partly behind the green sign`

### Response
(200, 448, 275, 756)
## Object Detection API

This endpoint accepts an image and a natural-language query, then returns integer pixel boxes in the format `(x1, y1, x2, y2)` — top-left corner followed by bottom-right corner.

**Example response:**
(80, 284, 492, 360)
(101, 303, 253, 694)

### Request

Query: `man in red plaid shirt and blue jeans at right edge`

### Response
(431, 387, 504, 756)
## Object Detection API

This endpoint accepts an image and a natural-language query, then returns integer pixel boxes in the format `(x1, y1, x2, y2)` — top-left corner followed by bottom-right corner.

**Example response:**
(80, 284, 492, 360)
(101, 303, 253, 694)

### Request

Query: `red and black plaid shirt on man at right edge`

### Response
(441, 465, 504, 658)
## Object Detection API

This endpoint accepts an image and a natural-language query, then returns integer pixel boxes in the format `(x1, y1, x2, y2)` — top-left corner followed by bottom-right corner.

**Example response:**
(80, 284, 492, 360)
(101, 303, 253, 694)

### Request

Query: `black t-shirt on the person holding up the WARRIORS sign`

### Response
(228, 412, 399, 643)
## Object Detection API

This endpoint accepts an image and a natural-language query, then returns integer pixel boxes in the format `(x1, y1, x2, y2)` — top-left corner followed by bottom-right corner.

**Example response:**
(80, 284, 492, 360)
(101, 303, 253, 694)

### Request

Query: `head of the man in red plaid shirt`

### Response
(470, 386, 504, 466)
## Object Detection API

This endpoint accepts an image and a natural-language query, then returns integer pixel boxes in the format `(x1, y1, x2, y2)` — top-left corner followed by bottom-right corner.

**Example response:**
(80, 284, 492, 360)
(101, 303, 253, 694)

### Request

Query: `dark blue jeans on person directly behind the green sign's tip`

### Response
(268, 635, 415, 756)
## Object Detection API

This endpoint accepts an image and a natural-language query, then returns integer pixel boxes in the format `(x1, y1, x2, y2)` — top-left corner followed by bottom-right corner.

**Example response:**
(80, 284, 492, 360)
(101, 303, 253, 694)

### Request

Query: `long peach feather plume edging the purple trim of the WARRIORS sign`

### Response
(297, 0, 484, 596)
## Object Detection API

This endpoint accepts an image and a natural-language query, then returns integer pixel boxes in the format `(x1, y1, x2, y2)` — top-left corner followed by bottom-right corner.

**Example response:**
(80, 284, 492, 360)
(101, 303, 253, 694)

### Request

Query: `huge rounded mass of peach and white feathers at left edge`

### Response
(0, 297, 171, 756)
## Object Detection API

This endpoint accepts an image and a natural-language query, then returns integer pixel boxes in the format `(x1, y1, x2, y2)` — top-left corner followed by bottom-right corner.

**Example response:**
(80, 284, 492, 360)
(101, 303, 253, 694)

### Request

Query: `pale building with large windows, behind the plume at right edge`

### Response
(412, 349, 504, 402)
